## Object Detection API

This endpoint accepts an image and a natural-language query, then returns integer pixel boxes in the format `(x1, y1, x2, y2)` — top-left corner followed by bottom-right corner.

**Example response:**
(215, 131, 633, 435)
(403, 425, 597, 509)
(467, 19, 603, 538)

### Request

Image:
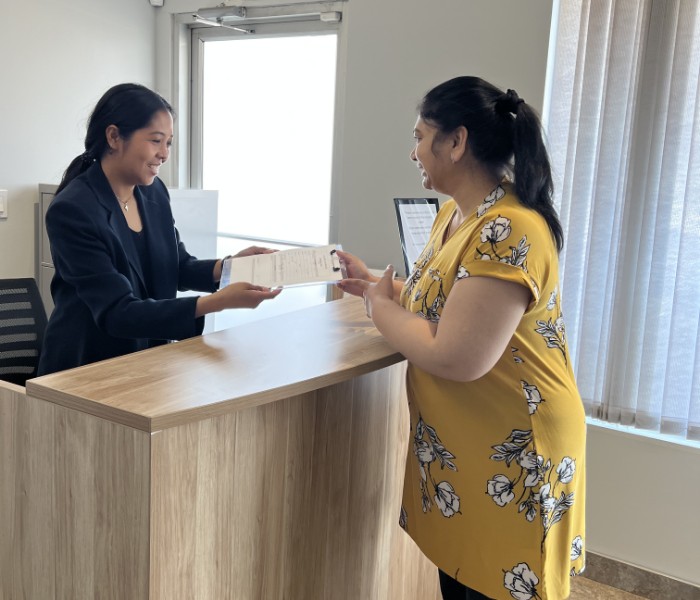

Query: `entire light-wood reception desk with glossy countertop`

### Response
(0, 298, 439, 600)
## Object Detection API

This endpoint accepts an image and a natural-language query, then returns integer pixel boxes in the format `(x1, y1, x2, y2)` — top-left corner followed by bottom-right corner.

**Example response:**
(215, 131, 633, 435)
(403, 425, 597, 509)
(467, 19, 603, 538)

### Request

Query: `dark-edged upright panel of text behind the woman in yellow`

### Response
(394, 198, 440, 276)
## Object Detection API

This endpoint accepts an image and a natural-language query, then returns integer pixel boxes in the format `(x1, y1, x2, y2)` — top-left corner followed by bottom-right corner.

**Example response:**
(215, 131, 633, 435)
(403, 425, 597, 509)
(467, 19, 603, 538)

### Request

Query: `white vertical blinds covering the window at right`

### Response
(544, 0, 700, 440)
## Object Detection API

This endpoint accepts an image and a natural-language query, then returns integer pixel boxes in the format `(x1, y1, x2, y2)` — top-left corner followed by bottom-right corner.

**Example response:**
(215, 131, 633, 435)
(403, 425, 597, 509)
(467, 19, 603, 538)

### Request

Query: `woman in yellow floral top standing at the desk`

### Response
(340, 77, 585, 600)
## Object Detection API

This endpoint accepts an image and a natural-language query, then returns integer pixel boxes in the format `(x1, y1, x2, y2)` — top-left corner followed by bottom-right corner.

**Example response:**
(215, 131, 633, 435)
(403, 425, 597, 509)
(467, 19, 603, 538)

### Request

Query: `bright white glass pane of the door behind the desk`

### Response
(202, 33, 337, 245)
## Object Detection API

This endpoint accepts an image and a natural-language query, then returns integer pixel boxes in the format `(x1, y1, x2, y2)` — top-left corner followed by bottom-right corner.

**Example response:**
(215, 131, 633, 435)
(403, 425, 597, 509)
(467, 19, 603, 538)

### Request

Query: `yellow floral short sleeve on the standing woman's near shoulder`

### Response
(456, 202, 553, 312)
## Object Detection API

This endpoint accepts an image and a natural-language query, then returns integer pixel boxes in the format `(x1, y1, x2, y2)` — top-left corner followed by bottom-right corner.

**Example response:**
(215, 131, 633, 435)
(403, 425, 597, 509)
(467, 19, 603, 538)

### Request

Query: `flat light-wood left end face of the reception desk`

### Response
(0, 388, 150, 600)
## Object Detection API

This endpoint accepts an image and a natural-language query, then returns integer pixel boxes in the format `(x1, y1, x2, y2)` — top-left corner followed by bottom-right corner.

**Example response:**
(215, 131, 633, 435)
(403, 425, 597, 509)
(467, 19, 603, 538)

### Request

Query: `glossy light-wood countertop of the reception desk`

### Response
(27, 297, 403, 432)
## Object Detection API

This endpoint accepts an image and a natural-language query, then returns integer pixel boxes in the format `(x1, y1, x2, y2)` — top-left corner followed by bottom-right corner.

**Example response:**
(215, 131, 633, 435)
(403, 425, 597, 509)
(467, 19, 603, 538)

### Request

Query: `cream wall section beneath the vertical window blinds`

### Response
(586, 424, 700, 586)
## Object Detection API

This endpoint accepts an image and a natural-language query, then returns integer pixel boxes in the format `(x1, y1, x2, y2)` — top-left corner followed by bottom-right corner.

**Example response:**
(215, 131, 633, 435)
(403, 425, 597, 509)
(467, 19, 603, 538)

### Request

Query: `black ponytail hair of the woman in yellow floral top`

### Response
(418, 77, 564, 250)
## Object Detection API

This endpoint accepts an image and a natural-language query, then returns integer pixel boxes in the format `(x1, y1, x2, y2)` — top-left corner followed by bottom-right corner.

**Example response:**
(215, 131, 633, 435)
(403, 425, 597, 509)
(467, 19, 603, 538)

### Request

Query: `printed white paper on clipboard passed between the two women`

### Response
(220, 244, 344, 288)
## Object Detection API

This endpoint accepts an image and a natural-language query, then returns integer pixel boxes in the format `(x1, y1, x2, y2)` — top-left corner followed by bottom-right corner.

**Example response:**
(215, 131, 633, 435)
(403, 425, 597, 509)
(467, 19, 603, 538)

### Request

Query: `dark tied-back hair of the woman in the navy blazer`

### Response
(56, 83, 174, 193)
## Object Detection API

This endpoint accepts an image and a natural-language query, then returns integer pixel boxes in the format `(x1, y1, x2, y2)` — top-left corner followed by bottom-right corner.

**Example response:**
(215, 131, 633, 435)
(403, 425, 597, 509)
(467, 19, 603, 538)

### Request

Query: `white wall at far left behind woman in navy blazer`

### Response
(0, 0, 155, 277)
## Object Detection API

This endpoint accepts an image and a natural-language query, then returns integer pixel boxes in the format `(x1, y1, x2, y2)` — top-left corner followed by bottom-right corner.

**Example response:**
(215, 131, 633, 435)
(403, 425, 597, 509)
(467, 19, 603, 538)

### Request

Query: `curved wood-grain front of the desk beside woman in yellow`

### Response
(151, 365, 438, 600)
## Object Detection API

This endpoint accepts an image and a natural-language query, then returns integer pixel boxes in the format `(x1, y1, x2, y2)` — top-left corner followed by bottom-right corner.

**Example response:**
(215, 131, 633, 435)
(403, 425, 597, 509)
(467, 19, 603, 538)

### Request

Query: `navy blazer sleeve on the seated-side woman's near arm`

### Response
(46, 197, 204, 340)
